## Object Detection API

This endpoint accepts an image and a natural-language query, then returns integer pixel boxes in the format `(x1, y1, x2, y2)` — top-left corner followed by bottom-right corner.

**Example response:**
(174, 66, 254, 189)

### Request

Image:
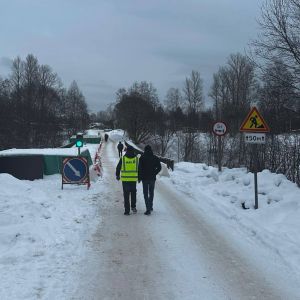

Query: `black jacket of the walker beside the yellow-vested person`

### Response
(139, 150, 161, 181)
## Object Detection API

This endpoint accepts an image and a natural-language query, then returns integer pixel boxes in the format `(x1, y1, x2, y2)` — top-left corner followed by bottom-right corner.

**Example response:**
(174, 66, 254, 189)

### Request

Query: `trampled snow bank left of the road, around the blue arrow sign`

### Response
(0, 145, 106, 299)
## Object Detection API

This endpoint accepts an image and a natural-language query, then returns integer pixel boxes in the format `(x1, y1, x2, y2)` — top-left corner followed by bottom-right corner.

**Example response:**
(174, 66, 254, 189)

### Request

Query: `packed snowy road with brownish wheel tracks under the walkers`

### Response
(72, 142, 297, 300)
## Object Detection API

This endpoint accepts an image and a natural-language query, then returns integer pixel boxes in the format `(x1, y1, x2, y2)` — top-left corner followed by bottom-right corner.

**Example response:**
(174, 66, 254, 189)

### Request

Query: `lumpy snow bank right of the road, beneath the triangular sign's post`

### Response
(161, 162, 300, 273)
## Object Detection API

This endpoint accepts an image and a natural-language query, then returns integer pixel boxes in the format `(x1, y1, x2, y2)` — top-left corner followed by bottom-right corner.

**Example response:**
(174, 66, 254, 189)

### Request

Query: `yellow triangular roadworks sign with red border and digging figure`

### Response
(240, 107, 270, 132)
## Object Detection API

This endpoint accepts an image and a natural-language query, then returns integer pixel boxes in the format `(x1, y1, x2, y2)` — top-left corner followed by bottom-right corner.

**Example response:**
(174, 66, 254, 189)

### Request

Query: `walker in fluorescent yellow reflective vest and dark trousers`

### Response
(116, 146, 139, 215)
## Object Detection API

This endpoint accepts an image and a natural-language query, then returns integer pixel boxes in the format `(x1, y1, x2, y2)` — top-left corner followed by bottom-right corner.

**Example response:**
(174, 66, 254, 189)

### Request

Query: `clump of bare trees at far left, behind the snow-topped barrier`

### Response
(0, 54, 89, 148)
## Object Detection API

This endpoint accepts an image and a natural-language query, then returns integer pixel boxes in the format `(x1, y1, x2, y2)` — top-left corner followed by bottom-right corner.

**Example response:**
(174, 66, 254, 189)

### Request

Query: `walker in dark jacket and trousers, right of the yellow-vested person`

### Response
(138, 145, 161, 215)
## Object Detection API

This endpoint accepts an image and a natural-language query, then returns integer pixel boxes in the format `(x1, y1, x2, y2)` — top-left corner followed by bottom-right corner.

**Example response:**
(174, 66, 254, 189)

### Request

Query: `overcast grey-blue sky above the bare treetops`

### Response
(0, 0, 262, 112)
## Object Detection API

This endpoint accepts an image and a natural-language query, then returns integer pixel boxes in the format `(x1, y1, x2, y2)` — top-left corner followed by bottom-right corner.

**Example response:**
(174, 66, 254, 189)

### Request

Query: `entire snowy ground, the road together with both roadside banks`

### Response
(0, 129, 300, 300)
